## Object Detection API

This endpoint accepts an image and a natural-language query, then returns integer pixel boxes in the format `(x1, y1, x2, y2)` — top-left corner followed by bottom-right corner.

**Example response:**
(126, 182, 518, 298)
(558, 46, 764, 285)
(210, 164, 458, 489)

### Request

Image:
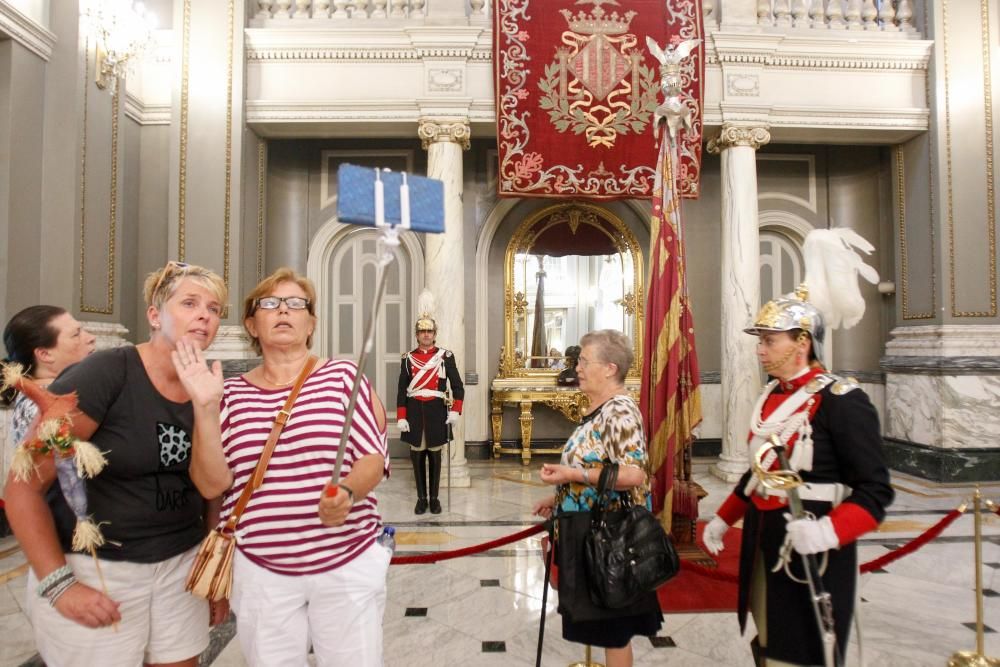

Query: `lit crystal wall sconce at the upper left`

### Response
(80, 0, 156, 92)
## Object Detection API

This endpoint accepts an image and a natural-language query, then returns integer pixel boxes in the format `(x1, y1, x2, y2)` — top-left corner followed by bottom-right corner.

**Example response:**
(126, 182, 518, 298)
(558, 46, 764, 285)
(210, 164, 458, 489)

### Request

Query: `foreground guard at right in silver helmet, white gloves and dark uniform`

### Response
(702, 230, 894, 667)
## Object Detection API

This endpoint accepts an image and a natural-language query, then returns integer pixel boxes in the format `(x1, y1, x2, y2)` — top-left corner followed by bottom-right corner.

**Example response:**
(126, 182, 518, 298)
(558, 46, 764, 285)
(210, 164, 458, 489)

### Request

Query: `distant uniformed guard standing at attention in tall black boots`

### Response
(396, 313, 465, 514)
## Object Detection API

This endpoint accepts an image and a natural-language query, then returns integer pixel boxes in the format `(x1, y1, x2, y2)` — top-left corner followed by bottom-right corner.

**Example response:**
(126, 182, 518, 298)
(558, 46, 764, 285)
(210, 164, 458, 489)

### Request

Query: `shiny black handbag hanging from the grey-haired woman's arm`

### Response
(584, 463, 681, 609)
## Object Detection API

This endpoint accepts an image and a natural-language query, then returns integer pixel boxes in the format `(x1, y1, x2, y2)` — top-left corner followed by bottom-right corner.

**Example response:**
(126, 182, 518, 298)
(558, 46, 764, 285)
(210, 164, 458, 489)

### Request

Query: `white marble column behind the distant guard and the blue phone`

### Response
(417, 118, 471, 487)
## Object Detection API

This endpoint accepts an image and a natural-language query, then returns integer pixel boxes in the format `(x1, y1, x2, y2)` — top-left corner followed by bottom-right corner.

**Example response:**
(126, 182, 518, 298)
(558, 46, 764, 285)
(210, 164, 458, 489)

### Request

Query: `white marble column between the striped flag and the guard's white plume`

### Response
(708, 125, 771, 482)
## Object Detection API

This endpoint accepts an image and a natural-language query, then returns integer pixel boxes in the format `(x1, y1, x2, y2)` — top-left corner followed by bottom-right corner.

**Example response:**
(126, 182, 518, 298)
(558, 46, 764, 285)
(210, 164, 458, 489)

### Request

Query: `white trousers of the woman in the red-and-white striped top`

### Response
(230, 542, 391, 667)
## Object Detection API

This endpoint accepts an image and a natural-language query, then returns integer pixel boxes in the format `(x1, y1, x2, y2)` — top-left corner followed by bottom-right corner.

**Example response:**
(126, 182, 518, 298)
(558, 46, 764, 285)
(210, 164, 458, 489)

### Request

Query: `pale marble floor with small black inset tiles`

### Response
(0, 458, 1000, 667)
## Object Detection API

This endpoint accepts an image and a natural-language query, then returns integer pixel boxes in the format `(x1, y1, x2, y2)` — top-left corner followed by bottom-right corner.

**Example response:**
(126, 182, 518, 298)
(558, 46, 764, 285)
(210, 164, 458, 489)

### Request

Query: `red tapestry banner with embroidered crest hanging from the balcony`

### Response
(493, 0, 705, 199)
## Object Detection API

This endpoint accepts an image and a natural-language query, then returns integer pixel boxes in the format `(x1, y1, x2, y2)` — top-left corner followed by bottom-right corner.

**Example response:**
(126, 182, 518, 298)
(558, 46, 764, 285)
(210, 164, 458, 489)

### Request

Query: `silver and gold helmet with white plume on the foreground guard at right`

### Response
(744, 227, 878, 366)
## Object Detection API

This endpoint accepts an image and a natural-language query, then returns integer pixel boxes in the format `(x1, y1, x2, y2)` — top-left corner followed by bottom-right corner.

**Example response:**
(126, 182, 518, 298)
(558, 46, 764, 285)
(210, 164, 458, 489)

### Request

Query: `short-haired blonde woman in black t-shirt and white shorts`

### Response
(6, 262, 227, 667)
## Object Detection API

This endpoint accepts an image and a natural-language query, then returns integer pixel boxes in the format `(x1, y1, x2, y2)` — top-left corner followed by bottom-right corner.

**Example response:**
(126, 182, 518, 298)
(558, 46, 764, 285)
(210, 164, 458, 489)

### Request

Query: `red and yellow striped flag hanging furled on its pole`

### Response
(639, 136, 701, 530)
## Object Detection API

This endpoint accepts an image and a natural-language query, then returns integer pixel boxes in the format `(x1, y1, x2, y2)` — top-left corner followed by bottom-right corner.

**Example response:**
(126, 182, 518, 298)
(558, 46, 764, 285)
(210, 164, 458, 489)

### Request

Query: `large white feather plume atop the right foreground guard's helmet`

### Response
(802, 227, 878, 329)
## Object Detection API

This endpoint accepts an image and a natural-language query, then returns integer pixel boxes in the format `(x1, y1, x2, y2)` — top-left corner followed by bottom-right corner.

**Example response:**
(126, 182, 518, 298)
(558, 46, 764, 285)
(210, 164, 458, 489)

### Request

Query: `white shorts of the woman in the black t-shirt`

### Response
(27, 546, 209, 667)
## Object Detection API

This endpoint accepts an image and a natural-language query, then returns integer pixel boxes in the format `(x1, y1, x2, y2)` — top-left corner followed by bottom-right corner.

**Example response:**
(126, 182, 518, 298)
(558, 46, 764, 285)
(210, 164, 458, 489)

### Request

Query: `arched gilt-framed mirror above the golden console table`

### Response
(499, 203, 644, 381)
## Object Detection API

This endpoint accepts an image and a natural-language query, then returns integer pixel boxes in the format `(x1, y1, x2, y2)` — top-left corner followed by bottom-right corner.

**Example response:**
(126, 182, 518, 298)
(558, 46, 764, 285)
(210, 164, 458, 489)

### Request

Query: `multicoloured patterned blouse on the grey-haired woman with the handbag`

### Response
(556, 394, 652, 512)
